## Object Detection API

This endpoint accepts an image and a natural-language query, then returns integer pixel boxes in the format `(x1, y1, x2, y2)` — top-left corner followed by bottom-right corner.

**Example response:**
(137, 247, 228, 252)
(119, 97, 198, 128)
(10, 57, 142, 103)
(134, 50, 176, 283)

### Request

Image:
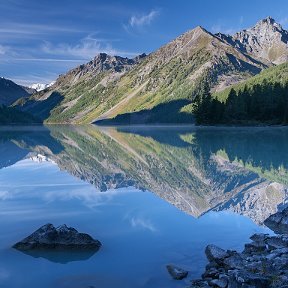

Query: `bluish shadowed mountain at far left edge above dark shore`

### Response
(0, 77, 31, 106)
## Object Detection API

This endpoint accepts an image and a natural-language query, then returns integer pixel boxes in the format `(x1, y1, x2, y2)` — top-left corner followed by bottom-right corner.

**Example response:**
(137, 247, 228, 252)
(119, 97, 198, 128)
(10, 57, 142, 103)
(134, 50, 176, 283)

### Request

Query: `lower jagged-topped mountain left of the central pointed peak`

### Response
(14, 53, 145, 123)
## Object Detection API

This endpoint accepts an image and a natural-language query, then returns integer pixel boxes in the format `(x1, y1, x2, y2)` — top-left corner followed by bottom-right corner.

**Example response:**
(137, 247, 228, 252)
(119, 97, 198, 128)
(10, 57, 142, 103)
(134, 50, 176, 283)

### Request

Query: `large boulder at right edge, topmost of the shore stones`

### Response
(264, 207, 288, 234)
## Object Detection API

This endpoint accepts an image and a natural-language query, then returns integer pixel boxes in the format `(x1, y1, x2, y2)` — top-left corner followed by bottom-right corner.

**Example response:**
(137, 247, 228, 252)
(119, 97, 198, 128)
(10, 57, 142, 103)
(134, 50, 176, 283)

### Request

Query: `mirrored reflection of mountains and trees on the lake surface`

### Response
(0, 125, 288, 224)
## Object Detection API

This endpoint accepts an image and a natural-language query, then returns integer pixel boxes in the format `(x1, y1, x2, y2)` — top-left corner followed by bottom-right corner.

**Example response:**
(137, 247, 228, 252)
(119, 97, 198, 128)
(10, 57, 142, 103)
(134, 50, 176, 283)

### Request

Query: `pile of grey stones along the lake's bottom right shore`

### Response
(190, 208, 288, 288)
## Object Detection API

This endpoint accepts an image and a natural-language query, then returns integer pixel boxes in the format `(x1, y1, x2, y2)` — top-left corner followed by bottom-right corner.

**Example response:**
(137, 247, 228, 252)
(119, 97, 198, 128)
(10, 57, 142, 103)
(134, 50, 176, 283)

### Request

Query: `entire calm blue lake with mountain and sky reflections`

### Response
(0, 125, 288, 288)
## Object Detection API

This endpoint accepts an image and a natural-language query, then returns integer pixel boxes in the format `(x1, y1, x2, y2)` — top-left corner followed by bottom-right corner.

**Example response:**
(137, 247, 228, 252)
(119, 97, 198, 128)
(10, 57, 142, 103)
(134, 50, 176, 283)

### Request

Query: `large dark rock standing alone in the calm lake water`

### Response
(13, 224, 101, 251)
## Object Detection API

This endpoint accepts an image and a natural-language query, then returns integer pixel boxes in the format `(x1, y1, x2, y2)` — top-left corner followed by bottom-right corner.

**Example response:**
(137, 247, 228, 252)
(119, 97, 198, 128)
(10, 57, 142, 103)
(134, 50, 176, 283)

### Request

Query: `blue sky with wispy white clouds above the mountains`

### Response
(0, 0, 288, 85)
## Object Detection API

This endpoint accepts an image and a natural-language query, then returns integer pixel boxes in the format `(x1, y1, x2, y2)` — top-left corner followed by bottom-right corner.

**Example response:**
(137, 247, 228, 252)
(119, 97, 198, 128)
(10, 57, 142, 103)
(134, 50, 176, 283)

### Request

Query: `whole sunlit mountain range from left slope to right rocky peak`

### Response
(14, 17, 288, 124)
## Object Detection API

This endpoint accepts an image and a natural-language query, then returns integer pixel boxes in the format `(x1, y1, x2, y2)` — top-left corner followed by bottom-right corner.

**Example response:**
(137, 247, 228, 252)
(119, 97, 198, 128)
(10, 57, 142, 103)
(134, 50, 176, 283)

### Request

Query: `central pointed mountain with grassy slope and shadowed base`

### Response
(94, 27, 261, 123)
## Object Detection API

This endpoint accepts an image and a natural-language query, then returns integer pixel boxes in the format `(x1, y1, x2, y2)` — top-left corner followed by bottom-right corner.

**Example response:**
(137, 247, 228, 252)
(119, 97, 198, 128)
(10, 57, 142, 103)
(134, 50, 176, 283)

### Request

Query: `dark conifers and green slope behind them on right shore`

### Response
(194, 63, 288, 125)
